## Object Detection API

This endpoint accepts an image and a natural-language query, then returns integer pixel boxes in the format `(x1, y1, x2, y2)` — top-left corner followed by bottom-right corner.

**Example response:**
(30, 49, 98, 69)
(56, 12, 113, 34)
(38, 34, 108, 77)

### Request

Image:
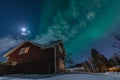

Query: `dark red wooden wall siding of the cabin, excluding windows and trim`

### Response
(4, 42, 65, 74)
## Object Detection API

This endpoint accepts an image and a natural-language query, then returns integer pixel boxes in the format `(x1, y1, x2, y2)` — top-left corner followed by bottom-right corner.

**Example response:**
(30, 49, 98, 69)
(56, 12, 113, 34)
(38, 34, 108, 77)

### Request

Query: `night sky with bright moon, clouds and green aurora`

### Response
(0, 0, 120, 62)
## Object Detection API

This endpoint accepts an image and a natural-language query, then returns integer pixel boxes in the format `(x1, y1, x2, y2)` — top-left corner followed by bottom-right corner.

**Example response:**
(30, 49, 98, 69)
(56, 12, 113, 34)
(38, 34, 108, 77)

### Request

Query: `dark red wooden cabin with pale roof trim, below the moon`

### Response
(4, 40, 65, 74)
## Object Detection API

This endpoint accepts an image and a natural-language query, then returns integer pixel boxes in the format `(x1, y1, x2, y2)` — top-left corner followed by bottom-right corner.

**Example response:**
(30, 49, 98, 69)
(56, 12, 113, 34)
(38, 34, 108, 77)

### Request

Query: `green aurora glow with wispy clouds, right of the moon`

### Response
(37, 0, 120, 62)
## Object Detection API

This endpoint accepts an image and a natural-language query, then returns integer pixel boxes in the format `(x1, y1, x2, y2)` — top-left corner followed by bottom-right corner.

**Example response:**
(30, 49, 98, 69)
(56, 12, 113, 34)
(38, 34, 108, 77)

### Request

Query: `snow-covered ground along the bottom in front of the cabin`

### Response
(0, 73, 120, 80)
